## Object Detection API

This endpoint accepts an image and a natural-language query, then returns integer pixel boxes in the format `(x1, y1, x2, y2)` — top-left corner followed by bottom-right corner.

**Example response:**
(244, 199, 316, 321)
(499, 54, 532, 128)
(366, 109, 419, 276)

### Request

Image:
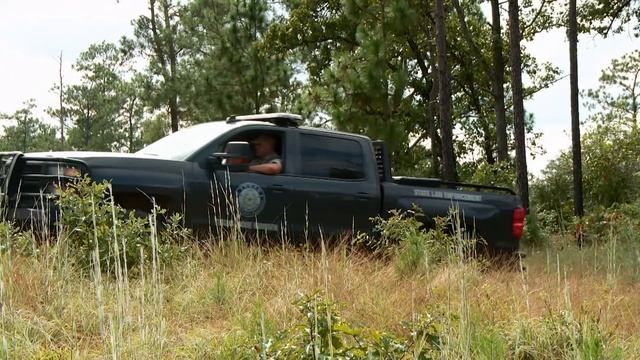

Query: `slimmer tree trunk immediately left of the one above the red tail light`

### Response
(491, 0, 509, 162)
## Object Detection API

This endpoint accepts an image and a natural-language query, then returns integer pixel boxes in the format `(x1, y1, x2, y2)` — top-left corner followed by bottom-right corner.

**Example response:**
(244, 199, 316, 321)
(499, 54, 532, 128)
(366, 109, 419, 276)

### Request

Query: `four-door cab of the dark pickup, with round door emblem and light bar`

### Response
(178, 117, 382, 234)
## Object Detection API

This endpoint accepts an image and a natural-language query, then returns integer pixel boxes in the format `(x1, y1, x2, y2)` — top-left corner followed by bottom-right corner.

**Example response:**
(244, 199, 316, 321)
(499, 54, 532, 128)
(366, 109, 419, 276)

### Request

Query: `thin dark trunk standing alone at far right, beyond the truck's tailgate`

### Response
(568, 0, 584, 245)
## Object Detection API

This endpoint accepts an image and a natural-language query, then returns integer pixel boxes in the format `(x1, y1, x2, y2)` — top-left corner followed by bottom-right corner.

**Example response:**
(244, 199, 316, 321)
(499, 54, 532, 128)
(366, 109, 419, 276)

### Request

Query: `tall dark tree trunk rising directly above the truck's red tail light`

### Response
(509, 0, 529, 210)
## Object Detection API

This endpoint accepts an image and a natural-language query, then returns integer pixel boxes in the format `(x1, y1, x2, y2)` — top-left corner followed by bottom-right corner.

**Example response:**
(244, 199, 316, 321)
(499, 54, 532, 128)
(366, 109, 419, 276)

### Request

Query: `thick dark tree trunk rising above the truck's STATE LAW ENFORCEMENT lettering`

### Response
(435, 0, 457, 181)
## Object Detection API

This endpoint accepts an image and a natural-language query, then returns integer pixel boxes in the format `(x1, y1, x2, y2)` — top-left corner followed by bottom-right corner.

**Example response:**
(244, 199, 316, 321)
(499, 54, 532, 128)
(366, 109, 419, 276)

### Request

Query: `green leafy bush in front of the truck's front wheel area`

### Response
(58, 177, 189, 274)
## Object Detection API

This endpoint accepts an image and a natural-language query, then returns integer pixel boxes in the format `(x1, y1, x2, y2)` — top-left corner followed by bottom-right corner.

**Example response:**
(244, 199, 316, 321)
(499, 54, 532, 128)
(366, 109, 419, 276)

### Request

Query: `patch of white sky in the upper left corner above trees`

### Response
(0, 0, 147, 113)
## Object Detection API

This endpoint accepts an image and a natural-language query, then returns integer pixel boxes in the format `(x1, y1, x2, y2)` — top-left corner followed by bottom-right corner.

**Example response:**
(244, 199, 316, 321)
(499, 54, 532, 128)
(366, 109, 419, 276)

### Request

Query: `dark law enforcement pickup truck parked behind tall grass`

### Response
(0, 114, 525, 251)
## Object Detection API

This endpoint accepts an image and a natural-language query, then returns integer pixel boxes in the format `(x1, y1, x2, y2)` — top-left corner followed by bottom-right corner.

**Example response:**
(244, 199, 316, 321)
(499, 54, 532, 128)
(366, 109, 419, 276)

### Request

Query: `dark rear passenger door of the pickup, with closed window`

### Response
(291, 131, 380, 234)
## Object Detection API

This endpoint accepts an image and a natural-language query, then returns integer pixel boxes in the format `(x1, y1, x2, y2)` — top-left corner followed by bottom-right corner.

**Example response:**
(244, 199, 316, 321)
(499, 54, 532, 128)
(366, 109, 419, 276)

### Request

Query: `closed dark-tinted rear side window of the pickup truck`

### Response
(300, 134, 365, 180)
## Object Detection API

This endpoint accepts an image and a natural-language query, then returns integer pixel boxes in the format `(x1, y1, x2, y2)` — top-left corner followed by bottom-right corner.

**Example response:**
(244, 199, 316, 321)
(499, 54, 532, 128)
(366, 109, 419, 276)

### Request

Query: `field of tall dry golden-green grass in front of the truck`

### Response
(0, 215, 640, 359)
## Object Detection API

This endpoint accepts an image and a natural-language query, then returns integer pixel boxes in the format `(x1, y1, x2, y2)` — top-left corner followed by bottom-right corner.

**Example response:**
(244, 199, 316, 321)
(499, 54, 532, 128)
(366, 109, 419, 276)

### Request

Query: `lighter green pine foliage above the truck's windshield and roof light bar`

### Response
(181, 0, 299, 122)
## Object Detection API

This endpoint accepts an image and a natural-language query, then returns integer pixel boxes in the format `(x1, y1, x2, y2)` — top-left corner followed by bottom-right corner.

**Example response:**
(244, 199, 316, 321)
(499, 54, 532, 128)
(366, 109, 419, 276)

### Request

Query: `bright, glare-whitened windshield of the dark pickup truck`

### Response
(137, 121, 233, 160)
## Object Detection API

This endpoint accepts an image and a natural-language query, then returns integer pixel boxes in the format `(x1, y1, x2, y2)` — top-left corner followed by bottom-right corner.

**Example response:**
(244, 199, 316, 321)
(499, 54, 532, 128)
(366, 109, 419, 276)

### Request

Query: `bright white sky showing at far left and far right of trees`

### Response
(0, 0, 640, 175)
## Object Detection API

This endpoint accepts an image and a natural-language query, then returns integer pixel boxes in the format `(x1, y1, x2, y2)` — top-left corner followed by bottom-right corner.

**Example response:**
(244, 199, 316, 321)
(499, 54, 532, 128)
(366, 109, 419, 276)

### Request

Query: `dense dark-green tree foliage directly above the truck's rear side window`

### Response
(265, 0, 431, 170)
